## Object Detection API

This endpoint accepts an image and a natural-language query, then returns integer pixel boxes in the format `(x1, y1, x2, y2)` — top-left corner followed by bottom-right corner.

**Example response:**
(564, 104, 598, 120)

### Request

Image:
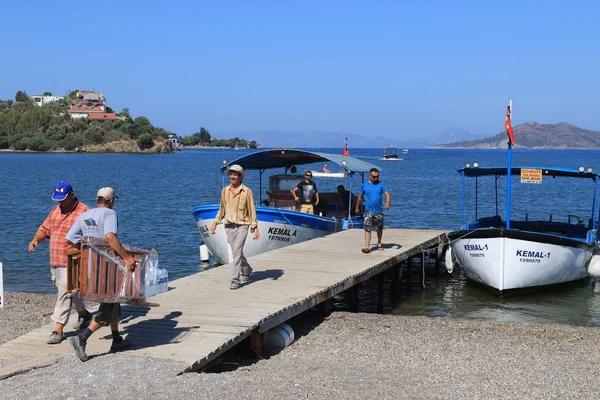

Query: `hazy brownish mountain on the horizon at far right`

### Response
(434, 122, 600, 149)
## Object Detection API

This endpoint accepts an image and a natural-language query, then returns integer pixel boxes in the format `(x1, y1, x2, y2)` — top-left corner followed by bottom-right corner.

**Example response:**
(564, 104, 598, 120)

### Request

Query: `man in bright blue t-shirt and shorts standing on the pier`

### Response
(354, 168, 392, 253)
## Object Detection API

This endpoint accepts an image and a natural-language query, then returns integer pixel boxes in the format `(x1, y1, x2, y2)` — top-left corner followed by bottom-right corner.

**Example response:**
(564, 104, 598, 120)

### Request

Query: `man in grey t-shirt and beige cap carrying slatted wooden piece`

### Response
(67, 187, 136, 361)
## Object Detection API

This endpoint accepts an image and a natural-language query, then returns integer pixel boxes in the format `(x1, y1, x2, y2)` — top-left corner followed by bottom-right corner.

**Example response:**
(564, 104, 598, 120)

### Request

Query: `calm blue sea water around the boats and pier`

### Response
(0, 149, 600, 324)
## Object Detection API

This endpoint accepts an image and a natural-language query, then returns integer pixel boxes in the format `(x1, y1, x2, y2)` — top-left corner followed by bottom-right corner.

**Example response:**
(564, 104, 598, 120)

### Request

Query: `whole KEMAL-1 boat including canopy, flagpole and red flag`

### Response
(446, 101, 600, 294)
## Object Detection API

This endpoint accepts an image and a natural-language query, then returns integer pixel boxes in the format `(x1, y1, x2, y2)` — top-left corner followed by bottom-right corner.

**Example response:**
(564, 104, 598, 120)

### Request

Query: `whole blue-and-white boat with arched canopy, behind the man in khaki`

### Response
(193, 149, 381, 264)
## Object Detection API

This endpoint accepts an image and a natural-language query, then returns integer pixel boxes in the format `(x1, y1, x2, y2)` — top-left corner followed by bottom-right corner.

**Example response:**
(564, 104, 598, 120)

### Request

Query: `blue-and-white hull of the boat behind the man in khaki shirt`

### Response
(193, 206, 363, 264)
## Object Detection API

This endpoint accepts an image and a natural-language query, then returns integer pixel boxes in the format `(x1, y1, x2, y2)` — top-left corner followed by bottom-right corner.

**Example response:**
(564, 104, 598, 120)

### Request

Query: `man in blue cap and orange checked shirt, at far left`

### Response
(29, 182, 92, 344)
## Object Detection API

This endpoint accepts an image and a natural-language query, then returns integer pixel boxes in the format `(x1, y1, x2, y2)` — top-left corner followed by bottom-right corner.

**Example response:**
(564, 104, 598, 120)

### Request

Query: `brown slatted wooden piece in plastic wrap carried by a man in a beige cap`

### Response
(67, 244, 148, 303)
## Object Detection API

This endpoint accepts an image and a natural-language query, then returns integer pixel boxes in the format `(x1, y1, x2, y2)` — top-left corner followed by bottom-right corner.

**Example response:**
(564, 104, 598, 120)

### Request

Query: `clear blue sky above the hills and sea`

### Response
(0, 0, 600, 139)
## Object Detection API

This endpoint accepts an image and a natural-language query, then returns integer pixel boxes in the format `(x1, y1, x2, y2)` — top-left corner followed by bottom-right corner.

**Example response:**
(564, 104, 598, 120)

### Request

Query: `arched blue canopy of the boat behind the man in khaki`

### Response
(221, 149, 382, 173)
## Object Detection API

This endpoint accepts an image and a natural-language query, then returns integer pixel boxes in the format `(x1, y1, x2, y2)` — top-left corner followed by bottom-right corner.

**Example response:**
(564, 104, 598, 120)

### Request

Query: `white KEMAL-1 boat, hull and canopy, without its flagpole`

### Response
(448, 166, 600, 294)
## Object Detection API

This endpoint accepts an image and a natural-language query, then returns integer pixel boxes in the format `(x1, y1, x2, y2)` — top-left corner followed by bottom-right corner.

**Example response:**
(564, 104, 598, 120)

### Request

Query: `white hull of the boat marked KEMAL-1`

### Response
(449, 229, 594, 292)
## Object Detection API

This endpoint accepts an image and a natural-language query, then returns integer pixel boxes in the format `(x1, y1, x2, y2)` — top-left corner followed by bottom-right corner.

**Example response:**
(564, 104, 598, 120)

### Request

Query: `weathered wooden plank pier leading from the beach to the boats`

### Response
(0, 229, 445, 372)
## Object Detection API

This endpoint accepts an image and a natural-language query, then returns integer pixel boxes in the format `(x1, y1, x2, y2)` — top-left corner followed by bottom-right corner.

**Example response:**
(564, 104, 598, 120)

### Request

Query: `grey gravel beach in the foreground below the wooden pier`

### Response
(0, 292, 600, 400)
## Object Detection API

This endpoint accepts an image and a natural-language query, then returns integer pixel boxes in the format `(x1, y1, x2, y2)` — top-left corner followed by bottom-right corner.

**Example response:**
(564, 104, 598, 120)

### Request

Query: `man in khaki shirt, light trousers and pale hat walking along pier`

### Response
(209, 164, 260, 289)
